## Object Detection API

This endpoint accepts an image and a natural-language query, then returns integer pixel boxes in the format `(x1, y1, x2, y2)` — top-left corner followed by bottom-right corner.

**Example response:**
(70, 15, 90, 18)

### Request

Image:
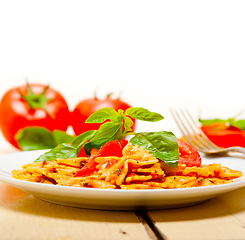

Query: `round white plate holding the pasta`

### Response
(0, 150, 245, 210)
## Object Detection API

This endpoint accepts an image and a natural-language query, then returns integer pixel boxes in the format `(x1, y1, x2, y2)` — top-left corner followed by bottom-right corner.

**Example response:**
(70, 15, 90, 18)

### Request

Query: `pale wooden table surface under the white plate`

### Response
(0, 149, 245, 240)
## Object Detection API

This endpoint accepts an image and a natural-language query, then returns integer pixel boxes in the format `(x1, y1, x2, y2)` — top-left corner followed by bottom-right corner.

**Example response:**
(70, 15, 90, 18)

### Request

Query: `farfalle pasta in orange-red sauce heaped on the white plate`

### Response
(12, 143, 242, 190)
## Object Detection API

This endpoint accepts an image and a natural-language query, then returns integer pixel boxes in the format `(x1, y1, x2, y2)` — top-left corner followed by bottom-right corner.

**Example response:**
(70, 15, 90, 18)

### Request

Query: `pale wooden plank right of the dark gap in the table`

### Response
(149, 188, 245, 240)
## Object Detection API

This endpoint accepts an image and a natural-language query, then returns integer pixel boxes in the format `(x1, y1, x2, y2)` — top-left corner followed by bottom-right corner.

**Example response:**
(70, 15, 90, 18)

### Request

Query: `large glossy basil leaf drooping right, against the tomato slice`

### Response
(130, 131, 179, 167)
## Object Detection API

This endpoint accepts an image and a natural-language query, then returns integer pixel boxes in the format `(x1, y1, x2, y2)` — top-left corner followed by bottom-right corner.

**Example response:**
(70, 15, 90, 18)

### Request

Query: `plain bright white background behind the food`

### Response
(0, 0, 245, 152)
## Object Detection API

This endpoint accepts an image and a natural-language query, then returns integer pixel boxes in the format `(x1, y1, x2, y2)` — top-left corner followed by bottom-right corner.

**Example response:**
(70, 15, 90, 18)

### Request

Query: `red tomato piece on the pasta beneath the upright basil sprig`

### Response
(75, 139, 128, 177)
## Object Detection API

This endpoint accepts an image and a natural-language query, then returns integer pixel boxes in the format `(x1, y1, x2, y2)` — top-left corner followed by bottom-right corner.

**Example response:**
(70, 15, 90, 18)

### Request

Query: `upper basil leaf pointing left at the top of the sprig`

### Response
(85, 107, 119, 123)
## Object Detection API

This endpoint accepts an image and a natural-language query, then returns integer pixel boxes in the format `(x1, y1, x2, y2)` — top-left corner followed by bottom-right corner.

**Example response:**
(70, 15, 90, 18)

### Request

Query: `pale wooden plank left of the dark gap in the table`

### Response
(0, 183, 152, 240)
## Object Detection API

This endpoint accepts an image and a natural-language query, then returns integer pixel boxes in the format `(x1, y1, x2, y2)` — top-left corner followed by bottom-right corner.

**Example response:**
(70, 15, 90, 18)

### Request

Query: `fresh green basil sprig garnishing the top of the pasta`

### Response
(35, 107, 179, 167)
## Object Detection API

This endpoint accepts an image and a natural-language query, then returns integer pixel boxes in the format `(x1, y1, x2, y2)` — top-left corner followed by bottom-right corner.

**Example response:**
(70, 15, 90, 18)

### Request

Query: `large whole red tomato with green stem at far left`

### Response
(0, 84, 70, 148)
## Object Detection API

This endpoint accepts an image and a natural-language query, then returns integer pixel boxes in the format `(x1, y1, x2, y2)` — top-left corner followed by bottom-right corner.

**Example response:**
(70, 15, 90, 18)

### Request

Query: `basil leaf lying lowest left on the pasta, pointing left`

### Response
(34, 143, 77, 162)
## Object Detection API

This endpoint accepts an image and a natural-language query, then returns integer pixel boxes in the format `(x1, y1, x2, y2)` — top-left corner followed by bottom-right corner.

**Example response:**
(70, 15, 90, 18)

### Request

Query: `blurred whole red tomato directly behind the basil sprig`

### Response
(72, 96, 135, 135)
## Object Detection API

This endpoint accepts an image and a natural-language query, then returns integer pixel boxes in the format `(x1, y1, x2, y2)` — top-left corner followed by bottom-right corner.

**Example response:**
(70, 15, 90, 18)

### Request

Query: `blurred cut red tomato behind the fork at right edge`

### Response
(201, 125, 245, 148)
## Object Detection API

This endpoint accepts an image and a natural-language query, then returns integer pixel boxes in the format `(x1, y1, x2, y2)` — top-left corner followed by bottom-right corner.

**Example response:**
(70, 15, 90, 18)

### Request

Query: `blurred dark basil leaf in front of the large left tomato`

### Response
(15, 127, 57, 151)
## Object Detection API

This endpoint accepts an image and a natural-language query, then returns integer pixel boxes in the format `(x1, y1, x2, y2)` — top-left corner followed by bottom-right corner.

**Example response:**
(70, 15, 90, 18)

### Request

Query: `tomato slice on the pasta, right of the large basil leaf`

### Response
(177, 139, 202, 167)
